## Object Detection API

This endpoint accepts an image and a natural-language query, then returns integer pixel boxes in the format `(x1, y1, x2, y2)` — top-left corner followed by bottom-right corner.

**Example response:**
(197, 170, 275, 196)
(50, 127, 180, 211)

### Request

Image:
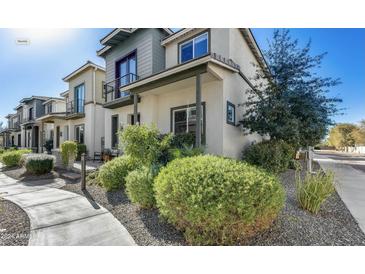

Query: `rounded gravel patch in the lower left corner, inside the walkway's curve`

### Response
(0, 200, 30, 246)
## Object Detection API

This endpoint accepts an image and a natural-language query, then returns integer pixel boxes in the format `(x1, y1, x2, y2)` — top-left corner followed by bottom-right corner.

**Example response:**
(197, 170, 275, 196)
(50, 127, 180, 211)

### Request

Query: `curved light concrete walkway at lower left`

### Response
(0, 167, 135, 246)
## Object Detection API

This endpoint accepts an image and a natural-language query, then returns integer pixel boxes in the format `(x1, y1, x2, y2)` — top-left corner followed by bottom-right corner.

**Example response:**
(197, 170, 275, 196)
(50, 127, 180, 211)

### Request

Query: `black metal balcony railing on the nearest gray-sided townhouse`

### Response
(104, 73, 139, 103)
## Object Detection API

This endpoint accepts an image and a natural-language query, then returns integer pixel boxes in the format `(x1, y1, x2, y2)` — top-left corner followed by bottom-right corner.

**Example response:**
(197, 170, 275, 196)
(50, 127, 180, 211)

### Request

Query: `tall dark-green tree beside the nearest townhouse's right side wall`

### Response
(240, 30, 341, 146)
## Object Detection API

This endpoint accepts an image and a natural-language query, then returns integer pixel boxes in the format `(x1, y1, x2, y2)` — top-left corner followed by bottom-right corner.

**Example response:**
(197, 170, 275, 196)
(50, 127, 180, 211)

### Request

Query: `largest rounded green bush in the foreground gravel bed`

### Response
(154, 155, 285, 245)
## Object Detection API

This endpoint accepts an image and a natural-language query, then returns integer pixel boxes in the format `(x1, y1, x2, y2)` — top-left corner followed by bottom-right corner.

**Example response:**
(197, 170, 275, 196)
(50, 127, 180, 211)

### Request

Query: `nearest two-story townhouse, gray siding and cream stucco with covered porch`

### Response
(98, 28, 267, 158)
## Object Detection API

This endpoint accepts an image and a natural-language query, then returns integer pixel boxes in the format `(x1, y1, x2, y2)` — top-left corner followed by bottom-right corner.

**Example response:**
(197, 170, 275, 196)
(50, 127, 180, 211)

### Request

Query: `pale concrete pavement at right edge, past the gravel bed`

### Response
(314, 152, 365, 233)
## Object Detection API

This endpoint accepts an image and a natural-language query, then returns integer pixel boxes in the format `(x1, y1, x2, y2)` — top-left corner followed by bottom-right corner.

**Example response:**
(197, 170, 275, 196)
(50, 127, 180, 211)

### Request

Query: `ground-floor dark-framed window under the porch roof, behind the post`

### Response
(171, 103, 205, 139)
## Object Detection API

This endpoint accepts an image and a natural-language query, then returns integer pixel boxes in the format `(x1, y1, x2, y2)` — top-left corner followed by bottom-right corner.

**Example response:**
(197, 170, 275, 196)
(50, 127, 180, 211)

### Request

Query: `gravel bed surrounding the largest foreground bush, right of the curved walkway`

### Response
(63, 161, 365, 246)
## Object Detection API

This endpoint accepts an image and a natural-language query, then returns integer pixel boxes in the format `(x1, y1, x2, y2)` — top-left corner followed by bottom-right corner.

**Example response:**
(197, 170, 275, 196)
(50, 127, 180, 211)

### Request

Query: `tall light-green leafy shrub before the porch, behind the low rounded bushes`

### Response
(120, 125, 172, 166)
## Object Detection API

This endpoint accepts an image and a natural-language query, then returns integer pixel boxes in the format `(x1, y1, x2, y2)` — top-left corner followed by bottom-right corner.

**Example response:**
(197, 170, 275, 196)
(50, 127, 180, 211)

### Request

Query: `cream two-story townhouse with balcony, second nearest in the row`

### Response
(38, 61, 105, 156)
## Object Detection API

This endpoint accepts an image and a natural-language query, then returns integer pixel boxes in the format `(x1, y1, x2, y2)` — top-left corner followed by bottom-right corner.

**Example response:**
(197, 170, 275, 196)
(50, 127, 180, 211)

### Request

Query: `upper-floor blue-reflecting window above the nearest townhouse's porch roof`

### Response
(179, 32, 209, 63)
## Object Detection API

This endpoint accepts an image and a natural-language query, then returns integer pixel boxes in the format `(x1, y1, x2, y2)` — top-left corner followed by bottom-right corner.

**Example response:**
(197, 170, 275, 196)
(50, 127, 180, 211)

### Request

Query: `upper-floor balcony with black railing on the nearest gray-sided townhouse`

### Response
(104, 73, 139, 109)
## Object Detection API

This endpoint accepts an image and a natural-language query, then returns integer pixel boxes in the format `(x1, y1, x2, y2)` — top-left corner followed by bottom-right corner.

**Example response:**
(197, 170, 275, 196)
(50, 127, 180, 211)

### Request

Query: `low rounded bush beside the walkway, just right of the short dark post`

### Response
(98, 156, 137, 191)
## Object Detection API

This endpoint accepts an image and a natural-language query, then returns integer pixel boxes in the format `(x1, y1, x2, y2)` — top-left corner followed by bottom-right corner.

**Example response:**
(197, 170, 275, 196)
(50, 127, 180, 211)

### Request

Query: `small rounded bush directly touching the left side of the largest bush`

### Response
(125, 167, 155, 208)
